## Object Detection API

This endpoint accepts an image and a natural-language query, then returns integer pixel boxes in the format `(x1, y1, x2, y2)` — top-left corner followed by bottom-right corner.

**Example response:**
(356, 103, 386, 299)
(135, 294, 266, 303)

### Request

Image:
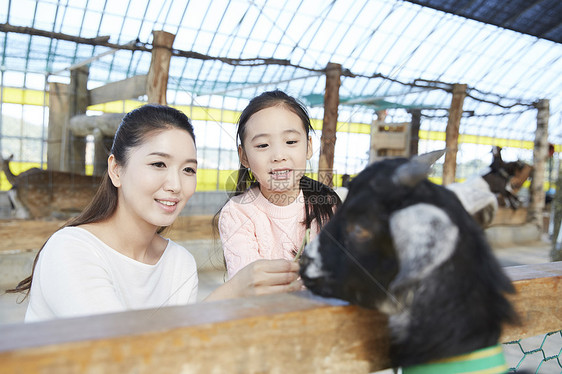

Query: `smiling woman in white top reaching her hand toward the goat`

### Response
(9, 105, 301, 322)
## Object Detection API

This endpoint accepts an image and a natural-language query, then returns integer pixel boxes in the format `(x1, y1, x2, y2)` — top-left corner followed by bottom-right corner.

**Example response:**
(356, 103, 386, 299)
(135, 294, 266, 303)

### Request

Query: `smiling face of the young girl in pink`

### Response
(238, 105, 312, 205)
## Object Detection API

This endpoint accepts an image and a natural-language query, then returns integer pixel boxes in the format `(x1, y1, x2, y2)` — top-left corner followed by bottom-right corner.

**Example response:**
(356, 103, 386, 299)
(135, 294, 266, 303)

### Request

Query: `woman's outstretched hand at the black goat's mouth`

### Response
(205, 260, 302, 301)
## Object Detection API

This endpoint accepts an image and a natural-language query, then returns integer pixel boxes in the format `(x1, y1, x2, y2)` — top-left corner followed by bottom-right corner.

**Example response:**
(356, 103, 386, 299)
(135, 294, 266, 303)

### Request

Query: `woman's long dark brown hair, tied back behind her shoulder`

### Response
(6, 104, 195, 299)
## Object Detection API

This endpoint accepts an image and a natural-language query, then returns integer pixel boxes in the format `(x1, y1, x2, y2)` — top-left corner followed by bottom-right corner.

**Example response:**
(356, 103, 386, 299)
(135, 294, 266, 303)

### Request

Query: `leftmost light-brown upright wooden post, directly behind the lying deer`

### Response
(47, 83, 69, 171)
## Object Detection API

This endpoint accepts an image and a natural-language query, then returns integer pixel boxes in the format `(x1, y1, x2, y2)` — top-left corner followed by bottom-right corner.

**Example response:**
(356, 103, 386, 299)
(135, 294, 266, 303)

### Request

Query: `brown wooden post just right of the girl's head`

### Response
(318, 62, 341, 187)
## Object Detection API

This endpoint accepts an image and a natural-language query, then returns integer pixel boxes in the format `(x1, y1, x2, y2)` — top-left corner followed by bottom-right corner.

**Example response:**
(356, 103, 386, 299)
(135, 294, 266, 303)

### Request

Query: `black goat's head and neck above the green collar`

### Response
(301, 152, 517, 373)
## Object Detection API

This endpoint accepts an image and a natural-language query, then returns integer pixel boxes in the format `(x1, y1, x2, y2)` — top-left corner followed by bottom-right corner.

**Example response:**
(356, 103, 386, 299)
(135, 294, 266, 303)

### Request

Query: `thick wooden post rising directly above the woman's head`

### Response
(146, 31, 176, 105)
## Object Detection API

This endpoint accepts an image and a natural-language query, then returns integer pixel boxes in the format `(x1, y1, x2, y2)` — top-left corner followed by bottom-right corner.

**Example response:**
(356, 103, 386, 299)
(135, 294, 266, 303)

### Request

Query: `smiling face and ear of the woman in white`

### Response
(108, 128, 197, 227)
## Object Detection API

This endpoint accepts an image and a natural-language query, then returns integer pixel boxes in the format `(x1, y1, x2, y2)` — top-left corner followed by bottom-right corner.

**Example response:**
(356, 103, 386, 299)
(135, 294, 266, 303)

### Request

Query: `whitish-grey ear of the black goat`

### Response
(390, 203, 459, 286)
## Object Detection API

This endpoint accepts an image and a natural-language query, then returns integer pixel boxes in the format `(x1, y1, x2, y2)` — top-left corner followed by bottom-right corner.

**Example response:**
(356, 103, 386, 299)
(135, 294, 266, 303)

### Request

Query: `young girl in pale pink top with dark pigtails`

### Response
(219, 90, 341, 277)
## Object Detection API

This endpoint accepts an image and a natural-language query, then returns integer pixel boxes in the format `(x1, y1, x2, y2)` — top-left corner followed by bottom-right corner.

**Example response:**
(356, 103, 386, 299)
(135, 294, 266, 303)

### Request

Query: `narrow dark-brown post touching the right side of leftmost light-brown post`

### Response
(64, 66, 89, 174)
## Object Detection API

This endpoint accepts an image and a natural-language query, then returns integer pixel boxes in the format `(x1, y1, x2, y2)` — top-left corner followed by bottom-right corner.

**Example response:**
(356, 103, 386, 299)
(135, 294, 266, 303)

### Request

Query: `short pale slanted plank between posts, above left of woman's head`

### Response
(90, 75, 147, 105)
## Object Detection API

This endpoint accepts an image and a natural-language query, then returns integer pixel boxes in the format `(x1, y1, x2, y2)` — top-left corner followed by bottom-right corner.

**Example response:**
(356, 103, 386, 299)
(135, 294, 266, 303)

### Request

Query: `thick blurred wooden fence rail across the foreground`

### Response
(0, 262, 562, 374)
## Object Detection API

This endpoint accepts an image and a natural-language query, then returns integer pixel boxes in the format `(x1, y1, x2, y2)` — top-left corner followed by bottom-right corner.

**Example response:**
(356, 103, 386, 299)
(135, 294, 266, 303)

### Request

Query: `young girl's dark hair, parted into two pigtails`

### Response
(220, 90, 341, 229)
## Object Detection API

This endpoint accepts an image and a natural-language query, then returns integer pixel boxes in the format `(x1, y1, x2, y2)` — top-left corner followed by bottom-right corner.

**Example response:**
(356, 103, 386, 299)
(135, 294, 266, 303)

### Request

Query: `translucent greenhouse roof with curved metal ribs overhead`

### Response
(0, 0, 562, 144)
